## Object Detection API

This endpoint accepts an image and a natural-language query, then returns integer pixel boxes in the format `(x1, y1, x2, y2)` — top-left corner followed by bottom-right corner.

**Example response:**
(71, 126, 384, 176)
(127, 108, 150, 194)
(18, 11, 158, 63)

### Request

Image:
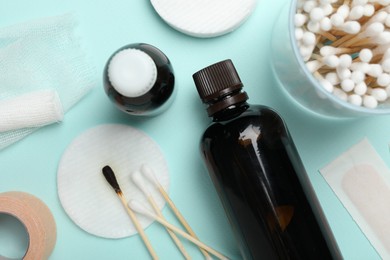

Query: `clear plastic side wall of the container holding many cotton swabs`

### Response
(271, 0, 390, 117)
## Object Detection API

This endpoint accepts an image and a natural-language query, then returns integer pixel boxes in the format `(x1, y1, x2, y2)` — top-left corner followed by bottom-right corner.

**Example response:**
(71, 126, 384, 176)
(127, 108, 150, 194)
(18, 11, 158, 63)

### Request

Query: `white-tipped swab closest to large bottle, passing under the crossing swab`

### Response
(141, 164, 210, 259)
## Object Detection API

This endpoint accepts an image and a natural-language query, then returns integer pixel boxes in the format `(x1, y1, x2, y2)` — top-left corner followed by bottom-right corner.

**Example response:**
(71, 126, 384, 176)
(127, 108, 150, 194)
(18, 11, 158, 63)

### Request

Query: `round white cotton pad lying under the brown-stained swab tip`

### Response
(57, 124, 169, 238)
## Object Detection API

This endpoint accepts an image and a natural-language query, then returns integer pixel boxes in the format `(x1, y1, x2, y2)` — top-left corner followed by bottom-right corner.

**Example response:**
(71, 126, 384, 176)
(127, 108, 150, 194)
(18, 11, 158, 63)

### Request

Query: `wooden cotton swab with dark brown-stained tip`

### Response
(102, 165, 158, 260)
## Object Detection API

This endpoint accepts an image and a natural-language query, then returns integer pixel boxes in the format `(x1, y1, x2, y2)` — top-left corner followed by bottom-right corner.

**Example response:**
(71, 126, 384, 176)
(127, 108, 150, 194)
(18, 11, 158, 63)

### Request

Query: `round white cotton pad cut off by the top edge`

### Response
(151, 0, 256, 38)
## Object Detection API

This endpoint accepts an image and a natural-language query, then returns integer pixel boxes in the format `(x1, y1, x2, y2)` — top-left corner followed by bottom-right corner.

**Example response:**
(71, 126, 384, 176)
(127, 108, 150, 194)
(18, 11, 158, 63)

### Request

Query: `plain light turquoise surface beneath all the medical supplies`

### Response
(0, 0, 390, 260)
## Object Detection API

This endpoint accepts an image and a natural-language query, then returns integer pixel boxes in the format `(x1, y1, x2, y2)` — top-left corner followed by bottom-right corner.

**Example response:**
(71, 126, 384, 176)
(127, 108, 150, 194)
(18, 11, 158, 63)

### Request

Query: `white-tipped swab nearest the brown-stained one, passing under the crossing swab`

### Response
(131, 171, 191, 259)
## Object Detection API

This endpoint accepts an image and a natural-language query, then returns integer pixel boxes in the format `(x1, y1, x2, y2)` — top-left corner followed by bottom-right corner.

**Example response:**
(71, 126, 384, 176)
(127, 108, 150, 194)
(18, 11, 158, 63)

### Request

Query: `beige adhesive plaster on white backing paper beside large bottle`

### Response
(320, 139, 390, 259)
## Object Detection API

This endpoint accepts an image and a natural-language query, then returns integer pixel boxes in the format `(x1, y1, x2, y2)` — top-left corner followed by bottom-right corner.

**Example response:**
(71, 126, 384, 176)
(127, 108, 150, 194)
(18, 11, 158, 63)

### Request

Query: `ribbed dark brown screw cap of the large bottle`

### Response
(192, 59, 248, 116)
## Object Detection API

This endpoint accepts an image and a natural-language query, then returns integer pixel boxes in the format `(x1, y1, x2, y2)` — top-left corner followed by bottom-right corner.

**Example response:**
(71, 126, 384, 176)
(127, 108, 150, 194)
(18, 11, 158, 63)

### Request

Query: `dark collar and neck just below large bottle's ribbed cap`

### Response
(207, 88, 249, 122)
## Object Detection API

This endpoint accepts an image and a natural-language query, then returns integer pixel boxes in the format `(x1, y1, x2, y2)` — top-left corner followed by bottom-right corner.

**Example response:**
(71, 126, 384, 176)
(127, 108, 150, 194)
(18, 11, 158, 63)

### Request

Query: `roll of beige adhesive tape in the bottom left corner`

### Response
(0, 191, 56, 260)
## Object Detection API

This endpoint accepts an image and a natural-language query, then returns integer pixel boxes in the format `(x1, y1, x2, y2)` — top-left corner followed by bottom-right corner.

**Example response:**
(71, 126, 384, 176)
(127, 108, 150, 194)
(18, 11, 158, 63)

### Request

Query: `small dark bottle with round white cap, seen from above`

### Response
(103, 43, 176, 116)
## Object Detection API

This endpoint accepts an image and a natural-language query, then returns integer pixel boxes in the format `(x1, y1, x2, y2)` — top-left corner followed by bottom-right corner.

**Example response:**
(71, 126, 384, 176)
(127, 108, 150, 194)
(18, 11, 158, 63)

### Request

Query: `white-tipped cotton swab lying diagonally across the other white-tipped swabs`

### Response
(128, 200, 228, 260)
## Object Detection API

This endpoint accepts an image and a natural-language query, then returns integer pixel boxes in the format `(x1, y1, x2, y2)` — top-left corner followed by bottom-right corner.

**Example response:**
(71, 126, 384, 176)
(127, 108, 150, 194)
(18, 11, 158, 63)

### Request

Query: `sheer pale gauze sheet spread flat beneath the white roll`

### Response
(0, 14, 97, 149)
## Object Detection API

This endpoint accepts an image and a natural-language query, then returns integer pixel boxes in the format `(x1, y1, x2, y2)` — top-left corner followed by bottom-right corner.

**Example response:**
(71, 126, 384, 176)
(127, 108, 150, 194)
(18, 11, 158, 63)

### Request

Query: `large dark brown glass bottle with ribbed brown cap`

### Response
(193, 60, 341, 260)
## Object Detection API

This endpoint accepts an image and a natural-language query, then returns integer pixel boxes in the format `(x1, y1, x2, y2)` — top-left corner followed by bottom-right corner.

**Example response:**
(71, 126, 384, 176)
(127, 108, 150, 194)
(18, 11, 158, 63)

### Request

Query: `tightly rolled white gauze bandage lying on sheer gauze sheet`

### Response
(0, 89, 64, 132)
